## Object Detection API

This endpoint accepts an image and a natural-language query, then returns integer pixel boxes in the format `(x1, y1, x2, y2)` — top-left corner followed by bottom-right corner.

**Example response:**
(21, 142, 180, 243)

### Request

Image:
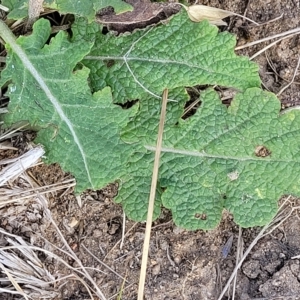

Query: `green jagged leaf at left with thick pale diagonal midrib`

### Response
(0, 19, 138, 192)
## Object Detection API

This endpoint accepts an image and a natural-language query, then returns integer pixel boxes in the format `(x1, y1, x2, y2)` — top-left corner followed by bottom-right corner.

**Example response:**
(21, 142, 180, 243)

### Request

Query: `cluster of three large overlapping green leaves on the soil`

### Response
(0, 13, 300, 229)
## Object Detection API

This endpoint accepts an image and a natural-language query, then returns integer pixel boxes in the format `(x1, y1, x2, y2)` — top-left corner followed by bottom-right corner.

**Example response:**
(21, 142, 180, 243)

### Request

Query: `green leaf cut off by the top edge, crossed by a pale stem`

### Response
(2, 0, 132, 21)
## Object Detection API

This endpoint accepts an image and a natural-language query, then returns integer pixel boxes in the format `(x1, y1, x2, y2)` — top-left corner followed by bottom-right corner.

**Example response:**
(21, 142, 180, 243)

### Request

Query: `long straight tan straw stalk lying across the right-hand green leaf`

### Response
(138, 89, 168, 300)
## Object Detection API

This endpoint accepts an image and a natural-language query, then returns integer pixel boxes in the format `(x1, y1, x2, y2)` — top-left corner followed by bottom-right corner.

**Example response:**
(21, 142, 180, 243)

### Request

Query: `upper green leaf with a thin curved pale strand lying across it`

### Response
(84, 12, 260, 102)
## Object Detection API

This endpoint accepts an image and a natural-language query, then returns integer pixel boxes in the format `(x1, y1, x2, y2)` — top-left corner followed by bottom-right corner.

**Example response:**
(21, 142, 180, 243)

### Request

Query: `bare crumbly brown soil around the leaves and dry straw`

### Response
(0, 0, 300, 300)
